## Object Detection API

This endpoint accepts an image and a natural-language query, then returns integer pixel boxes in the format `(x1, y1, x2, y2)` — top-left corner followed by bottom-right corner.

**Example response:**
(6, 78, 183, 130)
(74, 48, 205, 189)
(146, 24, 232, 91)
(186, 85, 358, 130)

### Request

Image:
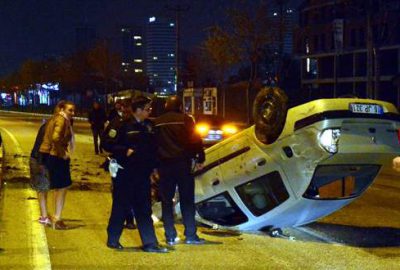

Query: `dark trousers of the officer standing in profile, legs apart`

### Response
(107, 167, 158, 247)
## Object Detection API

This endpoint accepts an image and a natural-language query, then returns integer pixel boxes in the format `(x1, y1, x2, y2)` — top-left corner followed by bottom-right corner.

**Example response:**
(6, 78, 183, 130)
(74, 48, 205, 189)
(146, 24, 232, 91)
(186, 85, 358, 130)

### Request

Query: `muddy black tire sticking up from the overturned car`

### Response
(253, 87, 288, 144)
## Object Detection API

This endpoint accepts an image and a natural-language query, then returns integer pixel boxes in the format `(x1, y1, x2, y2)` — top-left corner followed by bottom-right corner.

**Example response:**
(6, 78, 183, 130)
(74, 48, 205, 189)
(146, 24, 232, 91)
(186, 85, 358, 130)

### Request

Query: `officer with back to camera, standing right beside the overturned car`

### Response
(155, 96, 205, 245)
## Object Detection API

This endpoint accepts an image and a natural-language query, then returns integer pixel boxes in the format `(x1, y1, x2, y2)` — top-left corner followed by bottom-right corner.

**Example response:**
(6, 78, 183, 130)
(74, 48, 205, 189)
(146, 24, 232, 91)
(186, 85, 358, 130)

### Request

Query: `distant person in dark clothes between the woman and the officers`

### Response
(89, 101, 107, 155)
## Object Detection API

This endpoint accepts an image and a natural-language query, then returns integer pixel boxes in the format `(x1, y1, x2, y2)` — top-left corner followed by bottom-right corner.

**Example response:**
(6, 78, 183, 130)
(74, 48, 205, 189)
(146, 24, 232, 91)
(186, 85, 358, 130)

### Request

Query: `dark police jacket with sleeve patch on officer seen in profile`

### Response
(101, 117, 158, 169)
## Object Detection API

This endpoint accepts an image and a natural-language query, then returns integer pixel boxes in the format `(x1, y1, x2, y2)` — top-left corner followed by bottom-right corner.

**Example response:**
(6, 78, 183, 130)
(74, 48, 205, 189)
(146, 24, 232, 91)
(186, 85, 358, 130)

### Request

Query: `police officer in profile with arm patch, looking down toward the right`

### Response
(103, 97, 168, 253)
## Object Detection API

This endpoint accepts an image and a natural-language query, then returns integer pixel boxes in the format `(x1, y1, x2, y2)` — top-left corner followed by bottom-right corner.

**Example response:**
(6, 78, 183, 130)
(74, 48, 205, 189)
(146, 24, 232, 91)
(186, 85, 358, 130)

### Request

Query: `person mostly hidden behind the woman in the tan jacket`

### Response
(29, 101, 63, 226)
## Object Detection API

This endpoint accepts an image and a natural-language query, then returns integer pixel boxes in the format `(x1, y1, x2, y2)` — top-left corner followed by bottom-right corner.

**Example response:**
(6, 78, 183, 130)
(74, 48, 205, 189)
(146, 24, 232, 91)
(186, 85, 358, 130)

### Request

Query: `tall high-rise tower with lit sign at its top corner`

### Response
(146, 17, 176, 93)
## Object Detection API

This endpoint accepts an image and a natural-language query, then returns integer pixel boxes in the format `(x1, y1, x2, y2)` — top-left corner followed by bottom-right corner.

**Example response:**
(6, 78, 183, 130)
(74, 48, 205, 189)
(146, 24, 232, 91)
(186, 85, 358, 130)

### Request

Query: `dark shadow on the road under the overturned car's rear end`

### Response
(307, 222, 400, 248)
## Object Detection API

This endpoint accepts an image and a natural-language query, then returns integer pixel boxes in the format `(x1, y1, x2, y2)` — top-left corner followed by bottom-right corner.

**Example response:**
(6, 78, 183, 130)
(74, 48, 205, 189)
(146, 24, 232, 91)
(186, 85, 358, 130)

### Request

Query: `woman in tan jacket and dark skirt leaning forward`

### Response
(39, 101, 75, 230)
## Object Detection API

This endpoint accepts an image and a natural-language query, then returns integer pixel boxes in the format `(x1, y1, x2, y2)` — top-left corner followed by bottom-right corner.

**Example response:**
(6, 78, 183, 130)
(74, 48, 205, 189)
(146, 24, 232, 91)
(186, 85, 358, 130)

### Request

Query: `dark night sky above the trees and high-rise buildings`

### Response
(0, 0, 300, 75)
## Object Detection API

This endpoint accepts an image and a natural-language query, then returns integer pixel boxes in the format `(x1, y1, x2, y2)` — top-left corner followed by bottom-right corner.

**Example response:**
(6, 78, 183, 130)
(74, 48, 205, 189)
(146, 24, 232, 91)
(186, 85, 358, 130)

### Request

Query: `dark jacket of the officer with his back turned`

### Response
(155, 111, 205, 163)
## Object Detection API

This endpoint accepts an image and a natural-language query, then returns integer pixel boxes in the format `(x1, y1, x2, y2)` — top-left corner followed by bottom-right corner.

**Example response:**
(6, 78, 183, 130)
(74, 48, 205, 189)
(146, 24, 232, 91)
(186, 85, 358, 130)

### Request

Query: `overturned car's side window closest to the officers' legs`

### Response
(196, 192, 248, 226)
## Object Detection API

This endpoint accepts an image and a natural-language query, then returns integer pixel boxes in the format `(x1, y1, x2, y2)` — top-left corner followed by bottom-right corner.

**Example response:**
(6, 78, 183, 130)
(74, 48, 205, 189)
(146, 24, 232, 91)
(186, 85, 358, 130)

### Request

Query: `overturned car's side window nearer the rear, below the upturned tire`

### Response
(236, 171, 289, 216)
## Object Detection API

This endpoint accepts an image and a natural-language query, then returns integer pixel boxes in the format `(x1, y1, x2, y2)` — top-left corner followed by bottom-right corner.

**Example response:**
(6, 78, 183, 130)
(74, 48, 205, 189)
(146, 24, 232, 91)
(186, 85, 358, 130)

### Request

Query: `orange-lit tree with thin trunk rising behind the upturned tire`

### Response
(206, 1, 276, 123)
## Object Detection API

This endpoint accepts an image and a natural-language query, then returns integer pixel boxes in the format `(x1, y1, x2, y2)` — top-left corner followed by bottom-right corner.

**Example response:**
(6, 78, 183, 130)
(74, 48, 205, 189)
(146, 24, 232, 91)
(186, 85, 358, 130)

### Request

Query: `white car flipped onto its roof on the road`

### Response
(192, 88, 400, 230)
